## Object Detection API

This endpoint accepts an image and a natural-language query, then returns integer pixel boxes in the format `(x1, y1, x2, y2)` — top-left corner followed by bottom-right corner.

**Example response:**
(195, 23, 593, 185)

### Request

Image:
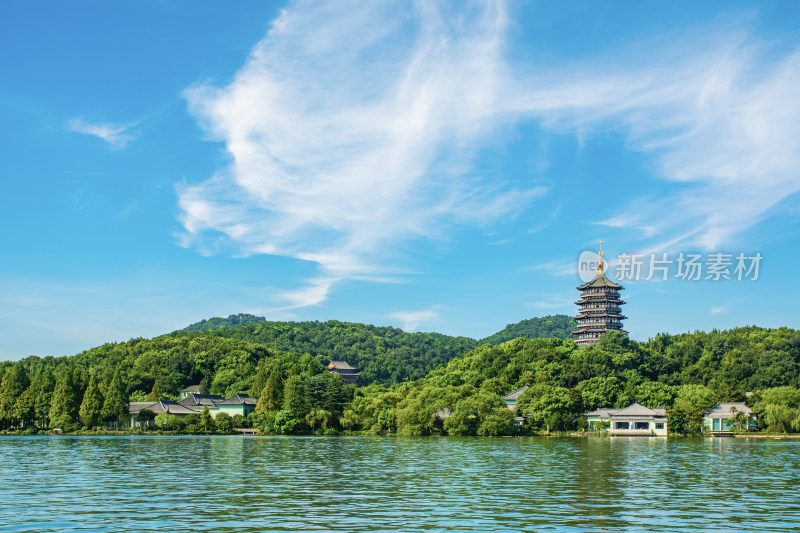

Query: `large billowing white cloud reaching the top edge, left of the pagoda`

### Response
(178, 2, 546, 305)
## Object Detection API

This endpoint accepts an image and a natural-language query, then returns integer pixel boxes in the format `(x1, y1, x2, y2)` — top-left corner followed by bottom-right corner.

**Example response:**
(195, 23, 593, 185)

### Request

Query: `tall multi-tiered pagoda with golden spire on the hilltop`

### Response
(572, 242, 627, 346)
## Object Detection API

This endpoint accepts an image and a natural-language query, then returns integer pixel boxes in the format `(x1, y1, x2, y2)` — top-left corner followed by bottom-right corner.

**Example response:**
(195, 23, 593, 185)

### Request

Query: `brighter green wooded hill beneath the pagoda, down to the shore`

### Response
(353, 327, 800, 435)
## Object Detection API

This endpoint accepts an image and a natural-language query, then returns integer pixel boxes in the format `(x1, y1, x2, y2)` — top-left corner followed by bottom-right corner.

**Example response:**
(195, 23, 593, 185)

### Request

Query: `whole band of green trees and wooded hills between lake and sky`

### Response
(0, 315, 800, 436)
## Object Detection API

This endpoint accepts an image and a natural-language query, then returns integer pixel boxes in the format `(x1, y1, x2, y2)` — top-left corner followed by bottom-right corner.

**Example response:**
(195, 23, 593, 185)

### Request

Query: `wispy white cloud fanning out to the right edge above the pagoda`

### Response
(511, 22, 800, 249)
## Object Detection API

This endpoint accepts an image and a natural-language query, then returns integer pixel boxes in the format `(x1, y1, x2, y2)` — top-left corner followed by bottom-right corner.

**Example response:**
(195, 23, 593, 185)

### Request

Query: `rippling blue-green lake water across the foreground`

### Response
(0, 437, 800, 532)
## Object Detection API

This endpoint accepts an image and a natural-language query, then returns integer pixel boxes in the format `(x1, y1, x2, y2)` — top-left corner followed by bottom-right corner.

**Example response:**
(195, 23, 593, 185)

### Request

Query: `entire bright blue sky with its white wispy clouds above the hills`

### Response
(0, 1, 800, 360)
